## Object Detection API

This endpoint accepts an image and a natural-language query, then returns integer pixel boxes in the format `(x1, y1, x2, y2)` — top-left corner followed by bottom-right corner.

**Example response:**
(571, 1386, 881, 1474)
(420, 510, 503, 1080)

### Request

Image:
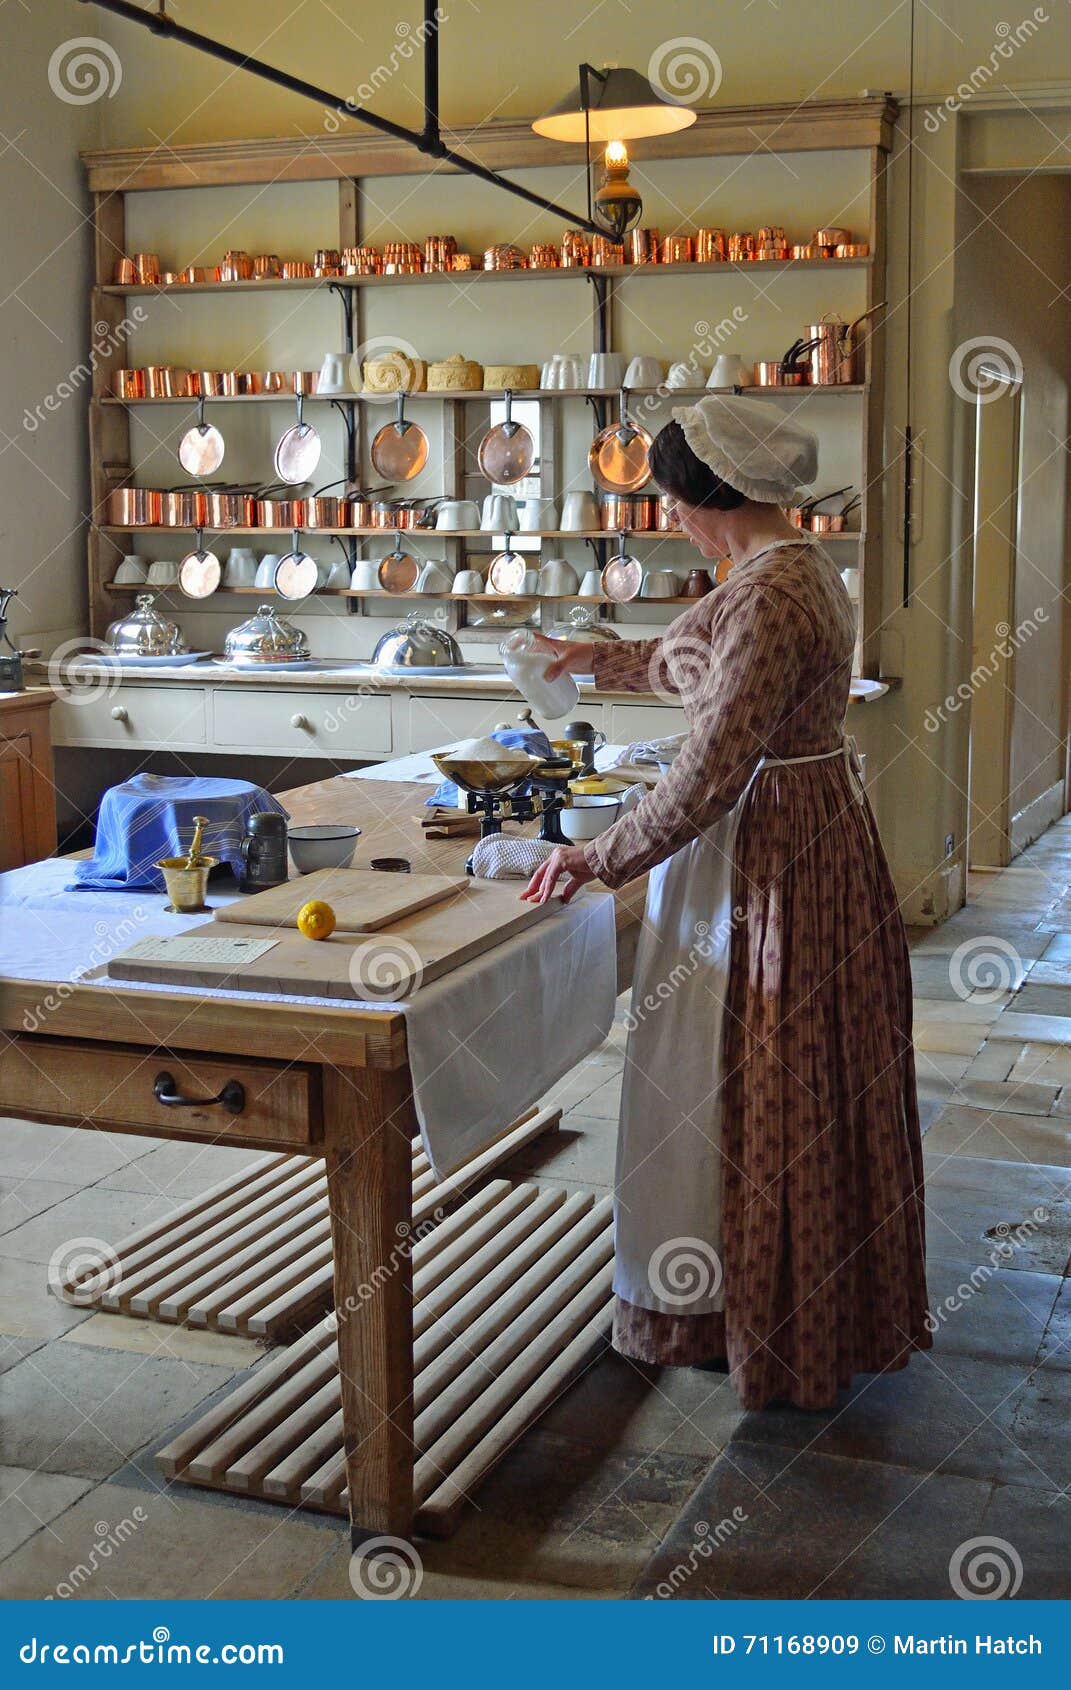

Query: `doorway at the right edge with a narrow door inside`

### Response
(949, 172, 1071, 870)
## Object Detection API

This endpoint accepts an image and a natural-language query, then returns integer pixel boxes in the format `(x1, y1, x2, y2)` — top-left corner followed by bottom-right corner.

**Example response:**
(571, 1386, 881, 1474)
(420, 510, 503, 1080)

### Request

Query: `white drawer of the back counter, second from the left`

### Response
(213, 686, 392, 759)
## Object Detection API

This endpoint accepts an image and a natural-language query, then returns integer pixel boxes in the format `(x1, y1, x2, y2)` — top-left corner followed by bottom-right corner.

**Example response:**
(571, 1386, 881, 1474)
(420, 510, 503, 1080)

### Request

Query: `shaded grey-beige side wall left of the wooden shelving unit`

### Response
(0, 0, 100, 647)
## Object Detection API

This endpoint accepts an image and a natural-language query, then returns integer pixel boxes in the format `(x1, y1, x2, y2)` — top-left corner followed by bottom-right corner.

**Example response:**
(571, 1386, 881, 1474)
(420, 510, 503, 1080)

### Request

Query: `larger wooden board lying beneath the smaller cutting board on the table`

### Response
(108, 880, 559, 1002)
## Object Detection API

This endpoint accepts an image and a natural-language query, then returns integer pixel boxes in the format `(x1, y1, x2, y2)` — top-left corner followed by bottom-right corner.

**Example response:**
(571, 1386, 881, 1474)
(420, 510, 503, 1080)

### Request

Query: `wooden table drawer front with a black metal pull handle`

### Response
(0, 1034, 321, 1149)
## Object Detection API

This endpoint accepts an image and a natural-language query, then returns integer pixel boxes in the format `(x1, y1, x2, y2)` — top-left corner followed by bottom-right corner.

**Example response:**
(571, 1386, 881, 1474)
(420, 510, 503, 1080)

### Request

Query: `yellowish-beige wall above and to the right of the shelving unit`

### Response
(41, 0, 1071, 918)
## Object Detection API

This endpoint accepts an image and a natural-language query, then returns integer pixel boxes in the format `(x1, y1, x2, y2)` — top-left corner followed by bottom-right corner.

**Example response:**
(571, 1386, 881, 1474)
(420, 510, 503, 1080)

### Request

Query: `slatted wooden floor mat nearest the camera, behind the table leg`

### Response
(157, 1180, 613, 1536)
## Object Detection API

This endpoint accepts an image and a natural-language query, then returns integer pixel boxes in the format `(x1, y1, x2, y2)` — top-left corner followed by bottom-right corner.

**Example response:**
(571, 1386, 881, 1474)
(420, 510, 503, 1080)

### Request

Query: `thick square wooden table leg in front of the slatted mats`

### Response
(323, 1066, 416, 1546)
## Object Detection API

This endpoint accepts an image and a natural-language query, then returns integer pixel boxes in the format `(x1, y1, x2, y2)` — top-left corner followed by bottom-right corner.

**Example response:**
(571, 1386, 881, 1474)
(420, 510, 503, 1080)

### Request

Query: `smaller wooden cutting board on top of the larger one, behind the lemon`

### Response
(216, 869, 471, 933)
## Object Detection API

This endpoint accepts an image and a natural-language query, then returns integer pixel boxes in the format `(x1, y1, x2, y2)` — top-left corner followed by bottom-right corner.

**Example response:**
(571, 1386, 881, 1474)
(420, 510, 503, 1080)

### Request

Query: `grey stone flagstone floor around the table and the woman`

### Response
(0, 818, 1071, 1599)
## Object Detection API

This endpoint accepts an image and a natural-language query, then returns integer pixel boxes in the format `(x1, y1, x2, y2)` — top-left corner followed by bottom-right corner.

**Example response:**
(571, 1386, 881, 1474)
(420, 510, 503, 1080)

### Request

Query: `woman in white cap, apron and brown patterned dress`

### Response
(524, 395, 931, 1408)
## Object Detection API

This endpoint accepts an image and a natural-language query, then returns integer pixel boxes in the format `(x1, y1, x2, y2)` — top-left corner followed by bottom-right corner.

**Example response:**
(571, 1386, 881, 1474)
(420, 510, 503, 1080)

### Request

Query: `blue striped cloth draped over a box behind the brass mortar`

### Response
(68, 774, 287, 892)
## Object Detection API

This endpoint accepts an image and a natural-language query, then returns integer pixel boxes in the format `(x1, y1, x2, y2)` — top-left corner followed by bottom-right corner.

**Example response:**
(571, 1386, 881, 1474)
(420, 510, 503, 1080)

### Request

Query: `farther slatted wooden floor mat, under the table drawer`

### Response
(56, 1109, 561, 1342)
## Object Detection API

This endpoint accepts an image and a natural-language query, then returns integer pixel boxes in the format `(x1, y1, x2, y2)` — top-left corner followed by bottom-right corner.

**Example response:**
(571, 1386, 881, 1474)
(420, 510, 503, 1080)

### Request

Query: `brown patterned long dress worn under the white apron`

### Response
(584, 542, 931, 1408)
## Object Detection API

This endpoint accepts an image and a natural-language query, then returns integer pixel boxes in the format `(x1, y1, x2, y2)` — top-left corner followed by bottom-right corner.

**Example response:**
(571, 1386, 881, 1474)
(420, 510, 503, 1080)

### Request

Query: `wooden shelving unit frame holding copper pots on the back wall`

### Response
(86, 96, 895, 676)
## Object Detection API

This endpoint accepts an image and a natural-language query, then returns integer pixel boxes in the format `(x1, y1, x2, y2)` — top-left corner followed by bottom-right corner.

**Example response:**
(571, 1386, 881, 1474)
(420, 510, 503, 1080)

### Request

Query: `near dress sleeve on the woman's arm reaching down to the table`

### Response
(584, 585, 816, 887)
